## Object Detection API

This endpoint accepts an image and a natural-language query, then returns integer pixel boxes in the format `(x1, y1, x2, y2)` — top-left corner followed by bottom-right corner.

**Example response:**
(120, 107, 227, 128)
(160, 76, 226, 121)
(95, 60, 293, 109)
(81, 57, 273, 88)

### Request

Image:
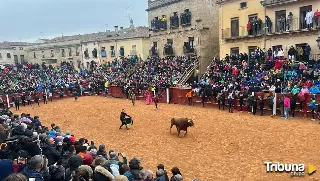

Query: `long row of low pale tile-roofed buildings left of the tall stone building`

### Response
(26, 24, 149, 68)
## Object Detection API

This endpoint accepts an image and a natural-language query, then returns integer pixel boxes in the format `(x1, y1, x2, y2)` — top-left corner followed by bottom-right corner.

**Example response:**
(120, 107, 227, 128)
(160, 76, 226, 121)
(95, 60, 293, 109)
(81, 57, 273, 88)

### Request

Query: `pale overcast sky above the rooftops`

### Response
(0, 0, 148, 42)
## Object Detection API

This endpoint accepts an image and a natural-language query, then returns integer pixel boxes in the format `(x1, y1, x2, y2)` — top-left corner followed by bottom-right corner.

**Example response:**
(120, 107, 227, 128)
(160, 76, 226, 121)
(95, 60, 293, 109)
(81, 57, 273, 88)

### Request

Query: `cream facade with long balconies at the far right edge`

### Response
(265, 0, 320, 60)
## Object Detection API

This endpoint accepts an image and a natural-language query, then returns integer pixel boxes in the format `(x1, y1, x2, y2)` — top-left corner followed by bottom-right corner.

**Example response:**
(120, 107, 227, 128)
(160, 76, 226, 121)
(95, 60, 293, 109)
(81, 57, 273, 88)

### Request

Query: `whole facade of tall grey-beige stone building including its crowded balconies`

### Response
(146, 0, 219, 73)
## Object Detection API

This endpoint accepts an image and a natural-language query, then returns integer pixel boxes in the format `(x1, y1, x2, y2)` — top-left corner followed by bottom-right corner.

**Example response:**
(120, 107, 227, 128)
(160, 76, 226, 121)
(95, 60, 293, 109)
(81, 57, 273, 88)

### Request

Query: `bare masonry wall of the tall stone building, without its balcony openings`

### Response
(147, 0, 219, 72)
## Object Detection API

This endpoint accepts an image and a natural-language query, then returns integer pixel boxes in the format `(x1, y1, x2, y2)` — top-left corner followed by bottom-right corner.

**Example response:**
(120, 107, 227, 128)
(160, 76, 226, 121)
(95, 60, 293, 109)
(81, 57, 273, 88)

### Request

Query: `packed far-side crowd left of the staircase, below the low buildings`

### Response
(0, 56, 196, 97)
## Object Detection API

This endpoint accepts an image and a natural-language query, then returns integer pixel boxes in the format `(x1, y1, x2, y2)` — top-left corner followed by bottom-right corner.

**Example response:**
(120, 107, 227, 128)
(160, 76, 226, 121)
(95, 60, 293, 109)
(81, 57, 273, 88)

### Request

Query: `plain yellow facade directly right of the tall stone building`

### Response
(217, 0, 265, 58)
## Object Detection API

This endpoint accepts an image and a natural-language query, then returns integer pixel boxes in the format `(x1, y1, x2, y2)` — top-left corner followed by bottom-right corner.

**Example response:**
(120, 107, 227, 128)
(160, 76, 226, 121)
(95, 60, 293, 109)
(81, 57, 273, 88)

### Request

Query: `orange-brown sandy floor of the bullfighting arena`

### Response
(11, 96, 320, 181)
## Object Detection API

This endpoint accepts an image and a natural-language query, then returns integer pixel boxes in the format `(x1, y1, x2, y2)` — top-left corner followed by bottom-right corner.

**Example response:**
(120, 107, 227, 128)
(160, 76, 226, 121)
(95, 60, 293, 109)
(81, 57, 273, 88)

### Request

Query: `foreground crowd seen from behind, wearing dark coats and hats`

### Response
(0, 109, 189, 181)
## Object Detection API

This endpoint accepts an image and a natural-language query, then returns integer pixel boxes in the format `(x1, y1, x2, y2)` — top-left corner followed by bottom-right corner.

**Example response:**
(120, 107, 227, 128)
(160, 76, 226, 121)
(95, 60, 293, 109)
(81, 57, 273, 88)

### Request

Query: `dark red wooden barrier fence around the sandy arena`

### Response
(0, 86, 320, 118)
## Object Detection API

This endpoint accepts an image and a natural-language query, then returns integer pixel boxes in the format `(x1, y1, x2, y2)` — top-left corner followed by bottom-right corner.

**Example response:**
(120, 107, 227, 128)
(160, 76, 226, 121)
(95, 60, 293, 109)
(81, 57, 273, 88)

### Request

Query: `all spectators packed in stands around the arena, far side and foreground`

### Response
(0, 41, 320, 181)
